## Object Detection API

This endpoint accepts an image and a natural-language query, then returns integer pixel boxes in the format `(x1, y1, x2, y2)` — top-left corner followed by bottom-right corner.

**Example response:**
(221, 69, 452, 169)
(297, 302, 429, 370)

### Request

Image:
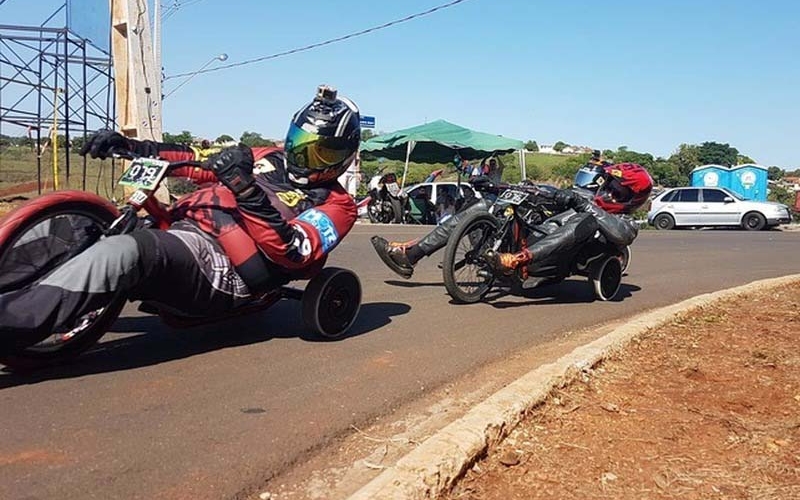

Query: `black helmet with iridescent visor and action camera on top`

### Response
(284, 85, 361, 188)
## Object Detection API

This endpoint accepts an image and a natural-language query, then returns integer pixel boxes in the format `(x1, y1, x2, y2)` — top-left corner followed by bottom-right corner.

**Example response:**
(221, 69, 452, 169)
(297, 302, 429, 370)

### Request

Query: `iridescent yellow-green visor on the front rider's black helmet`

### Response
(285, 123, 357, 170)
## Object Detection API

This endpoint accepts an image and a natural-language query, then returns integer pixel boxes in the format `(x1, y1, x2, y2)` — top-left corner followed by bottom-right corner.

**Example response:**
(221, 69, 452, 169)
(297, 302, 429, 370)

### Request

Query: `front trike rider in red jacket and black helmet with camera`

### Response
(0, 86, 361, 352)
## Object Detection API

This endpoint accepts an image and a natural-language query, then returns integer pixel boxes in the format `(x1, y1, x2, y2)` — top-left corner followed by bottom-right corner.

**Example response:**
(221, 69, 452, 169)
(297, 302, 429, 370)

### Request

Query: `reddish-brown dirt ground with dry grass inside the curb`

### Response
(446, 283, 800, 500)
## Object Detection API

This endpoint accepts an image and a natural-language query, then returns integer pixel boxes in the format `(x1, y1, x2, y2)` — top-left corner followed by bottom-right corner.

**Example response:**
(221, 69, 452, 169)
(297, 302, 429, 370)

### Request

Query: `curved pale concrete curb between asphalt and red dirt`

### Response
(348, 274, 800, 500)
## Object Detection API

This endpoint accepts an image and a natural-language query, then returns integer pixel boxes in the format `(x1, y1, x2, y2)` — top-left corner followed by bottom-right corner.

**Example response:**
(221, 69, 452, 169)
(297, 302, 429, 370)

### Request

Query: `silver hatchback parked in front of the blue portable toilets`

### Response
(647, 187, 791, 231)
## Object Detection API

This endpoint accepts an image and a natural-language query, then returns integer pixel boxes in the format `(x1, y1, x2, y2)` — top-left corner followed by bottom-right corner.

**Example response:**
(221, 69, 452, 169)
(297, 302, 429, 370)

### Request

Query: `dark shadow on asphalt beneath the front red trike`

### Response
(0, 302, 411, 389)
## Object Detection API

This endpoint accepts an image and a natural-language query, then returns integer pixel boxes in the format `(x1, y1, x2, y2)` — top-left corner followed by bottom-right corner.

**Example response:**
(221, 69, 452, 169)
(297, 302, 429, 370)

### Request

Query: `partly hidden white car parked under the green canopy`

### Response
(404, 181, 481, 224)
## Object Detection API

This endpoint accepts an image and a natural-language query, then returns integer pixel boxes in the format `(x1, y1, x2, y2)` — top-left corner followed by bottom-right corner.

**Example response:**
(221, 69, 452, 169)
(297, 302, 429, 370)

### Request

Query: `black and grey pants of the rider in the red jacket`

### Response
(0, 230, 250, 347)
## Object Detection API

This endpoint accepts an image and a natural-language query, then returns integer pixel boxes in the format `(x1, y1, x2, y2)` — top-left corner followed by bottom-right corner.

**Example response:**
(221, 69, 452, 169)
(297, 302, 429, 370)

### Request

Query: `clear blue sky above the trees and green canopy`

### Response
(0, 0, 800, 170)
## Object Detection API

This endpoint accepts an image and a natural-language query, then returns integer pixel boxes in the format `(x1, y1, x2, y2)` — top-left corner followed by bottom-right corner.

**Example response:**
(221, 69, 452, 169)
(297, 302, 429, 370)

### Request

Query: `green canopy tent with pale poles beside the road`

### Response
(361, 120, 525, 186)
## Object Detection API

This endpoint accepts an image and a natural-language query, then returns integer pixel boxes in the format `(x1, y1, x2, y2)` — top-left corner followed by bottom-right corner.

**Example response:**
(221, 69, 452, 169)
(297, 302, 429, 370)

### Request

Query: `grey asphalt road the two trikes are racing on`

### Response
(0, 225, 800, 500)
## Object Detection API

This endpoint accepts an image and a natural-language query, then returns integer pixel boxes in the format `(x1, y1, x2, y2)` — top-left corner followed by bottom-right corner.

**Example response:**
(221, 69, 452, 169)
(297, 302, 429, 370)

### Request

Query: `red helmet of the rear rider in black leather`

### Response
(594, 163, 653, 214)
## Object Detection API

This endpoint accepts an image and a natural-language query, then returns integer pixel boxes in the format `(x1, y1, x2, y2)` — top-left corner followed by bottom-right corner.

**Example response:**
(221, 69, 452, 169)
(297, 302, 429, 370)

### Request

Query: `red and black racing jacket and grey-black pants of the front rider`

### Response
(0, 141, 357, 348)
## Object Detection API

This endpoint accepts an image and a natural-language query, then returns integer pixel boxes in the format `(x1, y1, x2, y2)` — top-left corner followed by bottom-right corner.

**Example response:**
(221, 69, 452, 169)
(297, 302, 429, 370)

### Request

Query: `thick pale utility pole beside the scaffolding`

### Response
(109, 0, 169, 203)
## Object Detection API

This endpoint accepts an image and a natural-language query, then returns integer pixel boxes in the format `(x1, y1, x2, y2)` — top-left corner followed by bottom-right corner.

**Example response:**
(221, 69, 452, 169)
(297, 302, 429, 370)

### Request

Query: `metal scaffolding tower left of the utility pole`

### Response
(0, 0, 115, 193)
